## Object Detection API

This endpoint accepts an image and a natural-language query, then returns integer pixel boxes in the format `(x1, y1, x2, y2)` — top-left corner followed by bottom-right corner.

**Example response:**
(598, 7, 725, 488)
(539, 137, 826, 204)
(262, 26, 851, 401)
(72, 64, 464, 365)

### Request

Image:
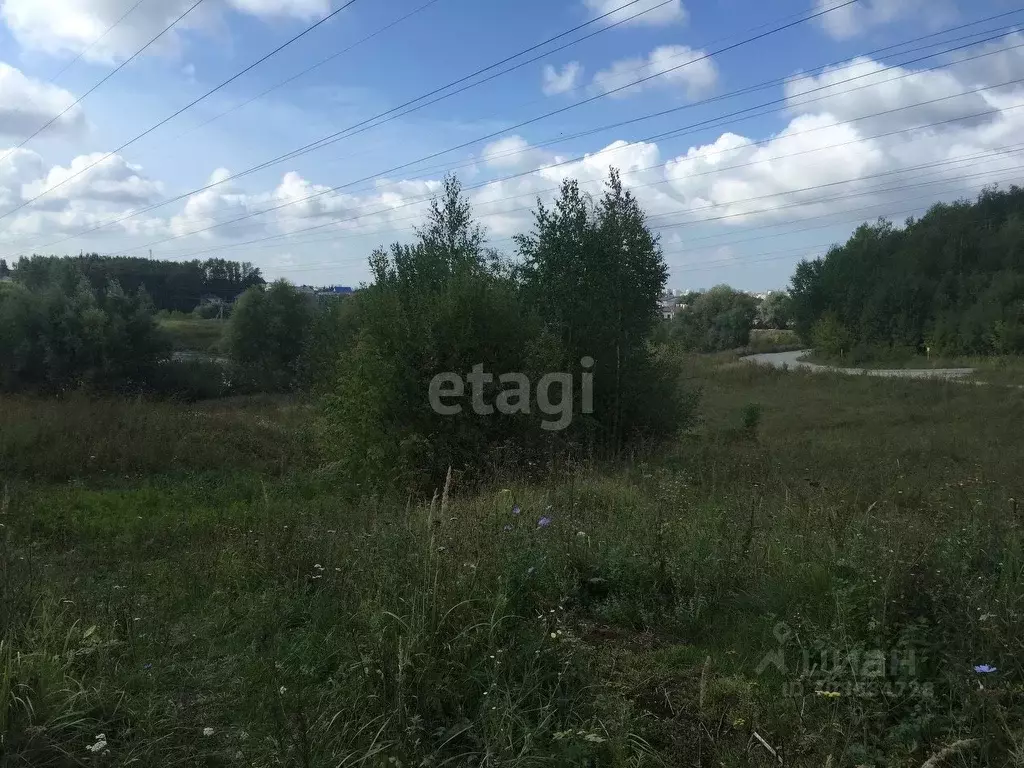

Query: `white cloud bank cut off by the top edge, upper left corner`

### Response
(0, 0, 331, 62)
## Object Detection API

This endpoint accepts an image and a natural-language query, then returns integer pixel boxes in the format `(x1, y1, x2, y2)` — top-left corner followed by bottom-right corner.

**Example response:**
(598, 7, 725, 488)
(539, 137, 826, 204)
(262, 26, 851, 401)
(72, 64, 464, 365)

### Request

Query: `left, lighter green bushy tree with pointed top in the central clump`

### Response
(323, 177, 552, 487)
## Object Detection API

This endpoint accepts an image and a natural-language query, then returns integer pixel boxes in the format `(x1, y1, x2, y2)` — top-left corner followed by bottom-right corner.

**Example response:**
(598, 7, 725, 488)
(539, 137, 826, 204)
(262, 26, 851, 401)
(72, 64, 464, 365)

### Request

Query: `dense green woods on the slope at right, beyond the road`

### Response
(791, 186, 1024, 358)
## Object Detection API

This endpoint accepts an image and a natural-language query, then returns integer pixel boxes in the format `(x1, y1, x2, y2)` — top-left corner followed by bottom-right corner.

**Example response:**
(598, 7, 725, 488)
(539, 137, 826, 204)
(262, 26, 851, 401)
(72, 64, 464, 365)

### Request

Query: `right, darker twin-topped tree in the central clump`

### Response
(517, 170, 687, 451)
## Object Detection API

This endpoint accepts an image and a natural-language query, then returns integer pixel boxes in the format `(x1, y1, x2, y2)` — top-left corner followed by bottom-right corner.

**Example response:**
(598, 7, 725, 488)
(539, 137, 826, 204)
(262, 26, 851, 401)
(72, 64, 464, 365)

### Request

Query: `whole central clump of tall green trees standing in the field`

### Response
(311, 173, 687, 486)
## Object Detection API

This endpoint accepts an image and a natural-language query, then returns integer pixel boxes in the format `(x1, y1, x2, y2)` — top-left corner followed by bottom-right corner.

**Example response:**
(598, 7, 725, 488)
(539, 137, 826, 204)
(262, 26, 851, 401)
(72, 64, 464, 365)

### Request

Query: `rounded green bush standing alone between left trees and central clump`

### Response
(224, 281, 316, 392)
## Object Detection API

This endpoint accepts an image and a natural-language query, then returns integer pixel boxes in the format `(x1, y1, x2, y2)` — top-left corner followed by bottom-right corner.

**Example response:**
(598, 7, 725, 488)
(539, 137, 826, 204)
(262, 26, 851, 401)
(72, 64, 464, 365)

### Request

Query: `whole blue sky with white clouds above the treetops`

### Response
(0, 0, 1024, 291)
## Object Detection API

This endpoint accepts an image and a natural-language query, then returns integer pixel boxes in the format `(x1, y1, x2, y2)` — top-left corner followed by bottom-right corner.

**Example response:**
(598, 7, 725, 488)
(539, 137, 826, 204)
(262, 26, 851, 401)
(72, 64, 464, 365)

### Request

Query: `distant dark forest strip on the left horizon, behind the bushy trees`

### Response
(9, 253, 264, 312)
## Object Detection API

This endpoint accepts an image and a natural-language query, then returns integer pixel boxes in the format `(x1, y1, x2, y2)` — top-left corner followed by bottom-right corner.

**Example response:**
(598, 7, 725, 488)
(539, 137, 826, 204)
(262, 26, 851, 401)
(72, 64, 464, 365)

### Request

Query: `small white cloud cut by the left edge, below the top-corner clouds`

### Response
(0, 61, 86, 140)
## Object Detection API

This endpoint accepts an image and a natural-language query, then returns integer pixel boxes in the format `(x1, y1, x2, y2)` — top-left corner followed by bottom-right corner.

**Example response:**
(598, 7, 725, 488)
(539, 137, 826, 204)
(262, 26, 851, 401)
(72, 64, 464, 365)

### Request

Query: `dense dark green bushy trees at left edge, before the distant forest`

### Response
(0, 273, 169, 392)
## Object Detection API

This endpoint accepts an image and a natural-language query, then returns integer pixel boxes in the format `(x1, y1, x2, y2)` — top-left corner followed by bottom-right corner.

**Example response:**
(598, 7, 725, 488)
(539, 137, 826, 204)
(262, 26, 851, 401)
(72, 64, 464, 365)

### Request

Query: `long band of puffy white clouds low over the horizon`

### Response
(0, 40, 1024, 282)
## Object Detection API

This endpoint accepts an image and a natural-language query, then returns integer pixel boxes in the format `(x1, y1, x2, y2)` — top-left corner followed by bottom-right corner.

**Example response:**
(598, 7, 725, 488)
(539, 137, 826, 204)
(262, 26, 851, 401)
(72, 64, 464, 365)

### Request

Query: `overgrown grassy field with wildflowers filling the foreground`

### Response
(0, 355, 1024, 768)
